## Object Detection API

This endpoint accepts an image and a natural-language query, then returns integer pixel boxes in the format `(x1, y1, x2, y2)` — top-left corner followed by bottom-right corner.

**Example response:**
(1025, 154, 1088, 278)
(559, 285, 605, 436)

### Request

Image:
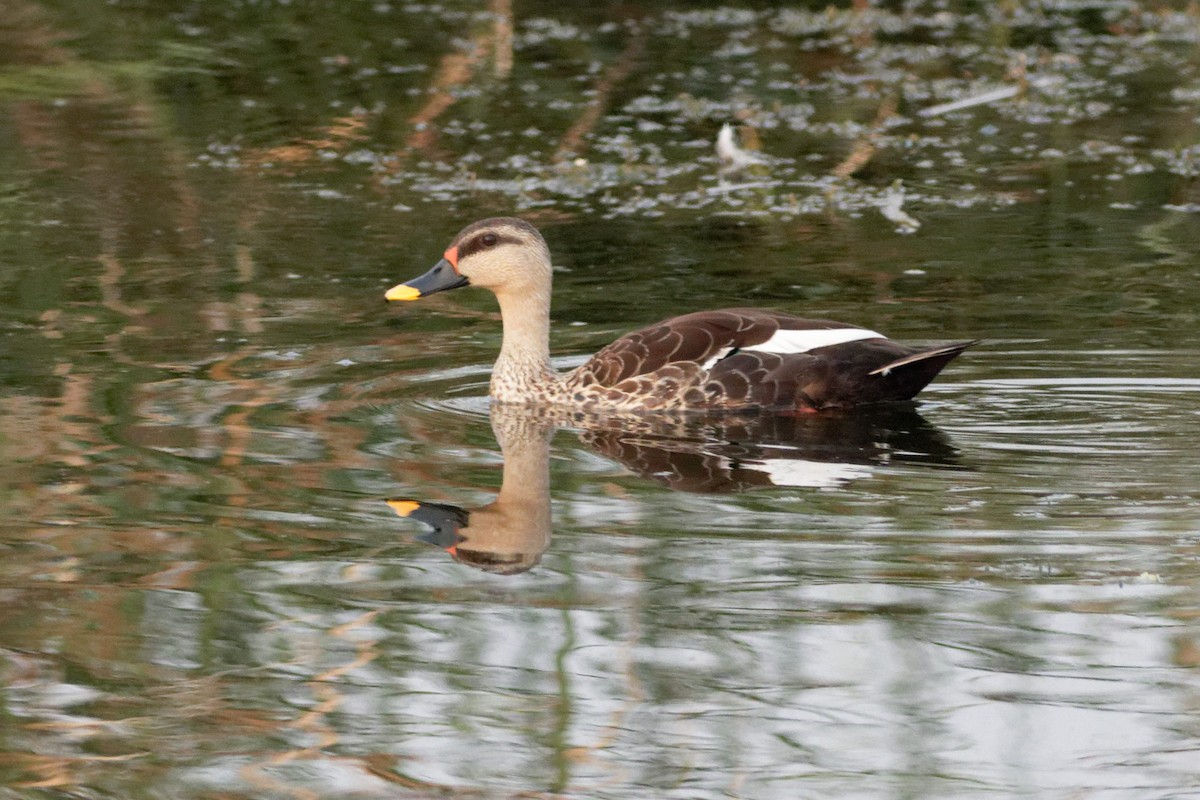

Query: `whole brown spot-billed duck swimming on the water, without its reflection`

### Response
(384, 217, 977, 414)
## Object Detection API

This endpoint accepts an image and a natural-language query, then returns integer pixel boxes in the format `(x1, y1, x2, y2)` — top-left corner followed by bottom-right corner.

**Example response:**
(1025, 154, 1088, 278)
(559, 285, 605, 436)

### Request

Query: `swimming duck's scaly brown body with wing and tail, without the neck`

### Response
(568, 308, 972, 410)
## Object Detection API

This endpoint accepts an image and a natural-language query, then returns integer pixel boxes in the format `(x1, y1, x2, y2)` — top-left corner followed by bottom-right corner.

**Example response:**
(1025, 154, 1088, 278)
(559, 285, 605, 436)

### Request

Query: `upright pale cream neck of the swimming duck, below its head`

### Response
(491, 290, 562, 403)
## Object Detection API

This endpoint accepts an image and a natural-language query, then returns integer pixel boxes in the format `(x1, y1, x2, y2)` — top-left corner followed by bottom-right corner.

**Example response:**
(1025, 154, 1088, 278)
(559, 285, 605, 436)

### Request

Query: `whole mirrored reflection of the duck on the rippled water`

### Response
(388, 404, 958, 575)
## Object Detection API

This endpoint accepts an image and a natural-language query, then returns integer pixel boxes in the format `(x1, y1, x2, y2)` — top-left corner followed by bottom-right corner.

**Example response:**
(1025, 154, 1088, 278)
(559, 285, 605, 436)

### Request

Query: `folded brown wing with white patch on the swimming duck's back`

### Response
(575, 308, 880, 387)
